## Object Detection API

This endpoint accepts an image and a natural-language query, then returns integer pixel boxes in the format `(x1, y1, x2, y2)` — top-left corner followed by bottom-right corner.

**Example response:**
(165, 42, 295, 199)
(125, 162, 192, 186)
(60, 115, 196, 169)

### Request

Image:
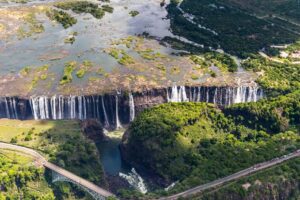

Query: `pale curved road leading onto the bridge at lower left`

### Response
(0, 142, 115, 197)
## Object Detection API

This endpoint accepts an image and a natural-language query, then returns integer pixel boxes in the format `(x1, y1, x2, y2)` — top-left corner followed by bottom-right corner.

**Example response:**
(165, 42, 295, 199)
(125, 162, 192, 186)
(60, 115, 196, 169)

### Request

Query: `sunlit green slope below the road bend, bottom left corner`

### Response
(0, 150, 55, 200)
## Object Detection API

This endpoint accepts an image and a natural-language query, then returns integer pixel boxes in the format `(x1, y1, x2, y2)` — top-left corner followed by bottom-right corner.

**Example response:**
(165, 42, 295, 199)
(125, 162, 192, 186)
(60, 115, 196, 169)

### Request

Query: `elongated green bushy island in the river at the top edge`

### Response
(55, 1, 107, 19)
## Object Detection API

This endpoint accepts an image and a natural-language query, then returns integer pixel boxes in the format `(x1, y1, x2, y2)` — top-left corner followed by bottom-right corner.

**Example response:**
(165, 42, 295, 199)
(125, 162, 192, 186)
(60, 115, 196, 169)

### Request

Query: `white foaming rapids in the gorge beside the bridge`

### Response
(119, 168, 148, 194)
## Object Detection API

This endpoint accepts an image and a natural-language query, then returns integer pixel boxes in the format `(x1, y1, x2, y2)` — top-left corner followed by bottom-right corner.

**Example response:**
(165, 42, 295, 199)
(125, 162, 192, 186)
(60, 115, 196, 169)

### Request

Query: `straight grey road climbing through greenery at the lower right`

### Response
(159, 150, 300, 200)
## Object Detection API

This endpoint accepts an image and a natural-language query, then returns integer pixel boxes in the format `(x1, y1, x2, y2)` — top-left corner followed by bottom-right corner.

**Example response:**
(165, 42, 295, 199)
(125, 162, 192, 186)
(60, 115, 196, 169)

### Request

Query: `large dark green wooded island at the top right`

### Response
(168, 0, 298, 58)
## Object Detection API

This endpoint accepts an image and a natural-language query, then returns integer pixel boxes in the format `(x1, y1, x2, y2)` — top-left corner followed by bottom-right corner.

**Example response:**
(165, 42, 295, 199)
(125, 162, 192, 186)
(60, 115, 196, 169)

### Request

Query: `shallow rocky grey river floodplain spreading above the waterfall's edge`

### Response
(0, 0, 256, 96)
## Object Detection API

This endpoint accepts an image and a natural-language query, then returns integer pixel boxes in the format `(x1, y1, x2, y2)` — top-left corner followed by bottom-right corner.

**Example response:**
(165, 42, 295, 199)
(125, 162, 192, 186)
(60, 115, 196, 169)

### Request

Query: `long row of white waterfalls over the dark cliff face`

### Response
(0, 85, 264, 129)
